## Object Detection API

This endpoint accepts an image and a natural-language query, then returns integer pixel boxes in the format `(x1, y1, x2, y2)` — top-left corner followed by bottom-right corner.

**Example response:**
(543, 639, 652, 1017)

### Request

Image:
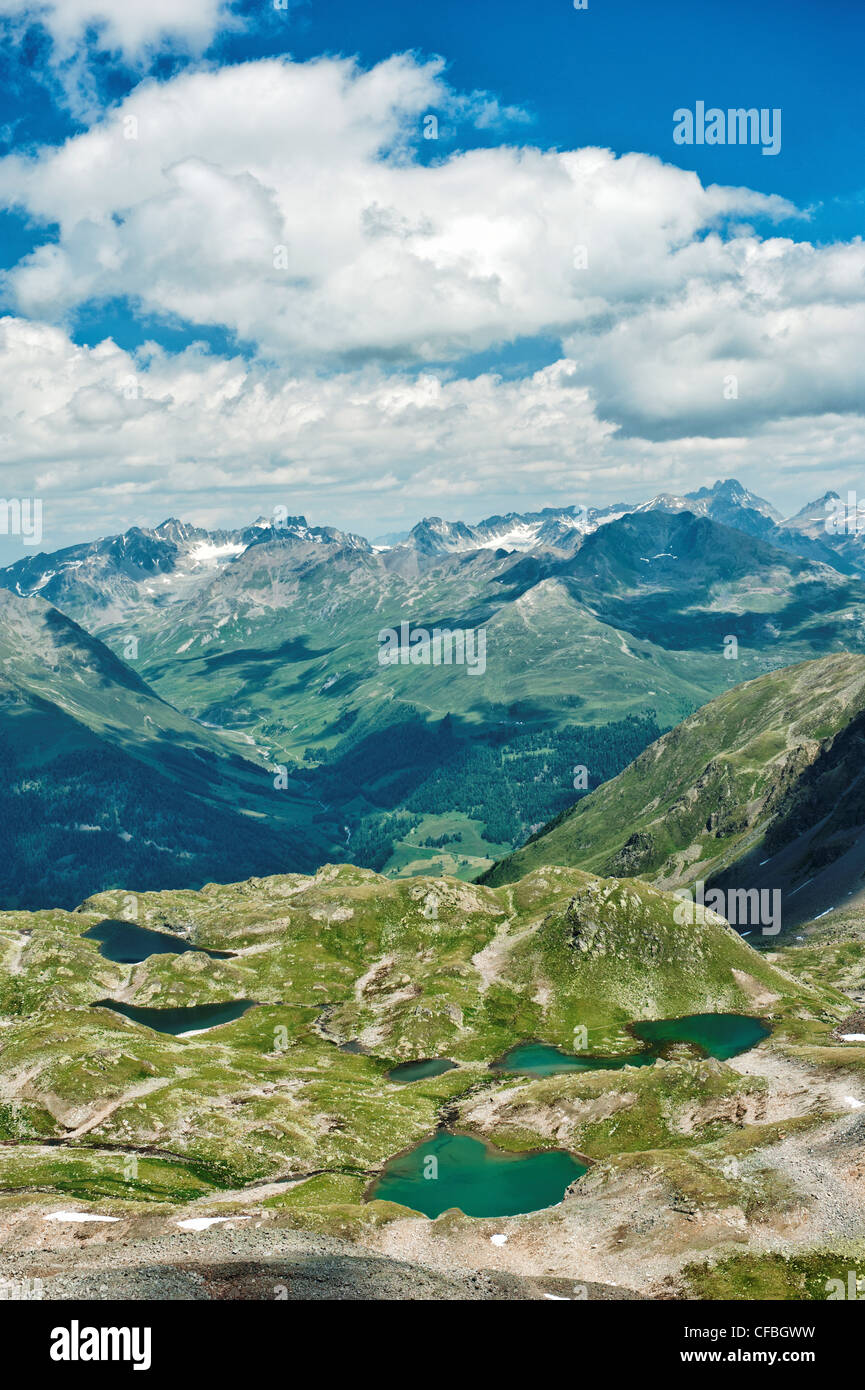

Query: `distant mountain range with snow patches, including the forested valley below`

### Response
(0, 481, 865, 904)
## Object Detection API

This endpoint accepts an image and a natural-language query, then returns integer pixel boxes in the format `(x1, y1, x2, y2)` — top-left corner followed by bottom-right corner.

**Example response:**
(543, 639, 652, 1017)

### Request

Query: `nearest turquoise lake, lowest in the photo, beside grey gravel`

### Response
(367, 1130, 585, 1218)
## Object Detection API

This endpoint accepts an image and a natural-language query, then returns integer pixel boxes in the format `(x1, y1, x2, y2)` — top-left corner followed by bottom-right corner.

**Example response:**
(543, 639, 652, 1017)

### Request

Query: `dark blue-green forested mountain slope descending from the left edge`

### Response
(0, 592, 332, 906)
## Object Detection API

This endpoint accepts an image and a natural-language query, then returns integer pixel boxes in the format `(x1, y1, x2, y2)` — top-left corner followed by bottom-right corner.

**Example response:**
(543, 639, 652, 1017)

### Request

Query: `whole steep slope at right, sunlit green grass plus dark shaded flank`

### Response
(484, 655, 865, 923)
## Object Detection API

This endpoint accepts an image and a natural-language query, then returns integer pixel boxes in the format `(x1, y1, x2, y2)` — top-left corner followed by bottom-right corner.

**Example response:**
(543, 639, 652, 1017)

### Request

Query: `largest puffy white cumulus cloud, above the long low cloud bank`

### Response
(0, 56, 791, 372)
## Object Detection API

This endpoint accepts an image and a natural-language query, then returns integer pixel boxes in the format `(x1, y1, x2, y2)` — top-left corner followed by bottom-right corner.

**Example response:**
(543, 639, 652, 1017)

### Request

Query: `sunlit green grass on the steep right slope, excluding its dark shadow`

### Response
(481, 653, 865, 884)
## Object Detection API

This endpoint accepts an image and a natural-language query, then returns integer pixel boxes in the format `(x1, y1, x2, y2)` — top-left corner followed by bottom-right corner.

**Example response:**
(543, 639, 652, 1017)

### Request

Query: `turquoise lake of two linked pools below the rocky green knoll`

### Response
(492, 1013, 772, 1076)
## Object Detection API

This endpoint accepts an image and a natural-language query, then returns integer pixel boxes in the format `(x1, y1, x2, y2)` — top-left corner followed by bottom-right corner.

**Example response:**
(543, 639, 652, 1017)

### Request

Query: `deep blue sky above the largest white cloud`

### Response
(6, 0, 865, 205)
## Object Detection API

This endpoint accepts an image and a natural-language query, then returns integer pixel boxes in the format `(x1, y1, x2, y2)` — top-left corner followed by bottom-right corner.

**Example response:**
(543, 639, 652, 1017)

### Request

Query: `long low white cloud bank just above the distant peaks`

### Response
(0, 318, 865, 549)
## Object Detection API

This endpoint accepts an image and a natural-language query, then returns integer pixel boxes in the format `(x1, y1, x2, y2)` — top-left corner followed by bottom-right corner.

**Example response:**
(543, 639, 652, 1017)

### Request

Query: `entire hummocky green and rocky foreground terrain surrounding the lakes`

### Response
(0, 866, 865, 1298)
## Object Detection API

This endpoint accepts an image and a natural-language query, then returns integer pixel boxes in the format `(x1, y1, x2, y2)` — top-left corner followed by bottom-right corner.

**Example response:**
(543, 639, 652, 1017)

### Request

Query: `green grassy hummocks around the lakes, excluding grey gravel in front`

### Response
(0, 866, 844, 1193)
